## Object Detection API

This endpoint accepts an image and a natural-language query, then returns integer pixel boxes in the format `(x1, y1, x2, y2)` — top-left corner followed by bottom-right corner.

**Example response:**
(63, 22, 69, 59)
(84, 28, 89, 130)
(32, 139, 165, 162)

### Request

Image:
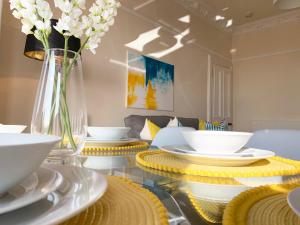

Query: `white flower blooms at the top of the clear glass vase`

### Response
(9, 0, 120, 53)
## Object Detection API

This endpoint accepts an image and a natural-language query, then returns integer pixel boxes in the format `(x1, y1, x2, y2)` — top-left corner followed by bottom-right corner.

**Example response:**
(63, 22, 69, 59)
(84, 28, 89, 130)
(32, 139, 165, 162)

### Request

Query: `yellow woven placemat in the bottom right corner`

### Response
(223, 183, 300, 225)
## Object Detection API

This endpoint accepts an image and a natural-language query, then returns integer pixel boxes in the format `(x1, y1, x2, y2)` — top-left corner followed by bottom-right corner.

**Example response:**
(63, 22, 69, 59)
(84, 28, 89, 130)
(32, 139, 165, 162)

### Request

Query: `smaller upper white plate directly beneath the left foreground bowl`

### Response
(0, 167, 63, 214)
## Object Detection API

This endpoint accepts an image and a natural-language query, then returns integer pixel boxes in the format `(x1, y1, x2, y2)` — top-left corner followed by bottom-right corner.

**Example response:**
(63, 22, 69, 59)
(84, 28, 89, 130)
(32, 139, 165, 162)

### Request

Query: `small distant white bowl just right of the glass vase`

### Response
(88, 127, 130, 140)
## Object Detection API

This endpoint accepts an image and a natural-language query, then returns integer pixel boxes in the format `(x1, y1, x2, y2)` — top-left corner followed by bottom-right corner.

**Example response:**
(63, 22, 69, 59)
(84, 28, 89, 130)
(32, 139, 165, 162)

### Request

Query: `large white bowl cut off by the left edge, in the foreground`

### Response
(0, 134, 60, 193)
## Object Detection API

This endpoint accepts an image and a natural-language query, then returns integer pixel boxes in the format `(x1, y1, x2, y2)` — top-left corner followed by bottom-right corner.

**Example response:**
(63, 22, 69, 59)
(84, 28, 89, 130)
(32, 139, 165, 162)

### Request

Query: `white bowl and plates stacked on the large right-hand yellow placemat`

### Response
(162, 131, 275, 166)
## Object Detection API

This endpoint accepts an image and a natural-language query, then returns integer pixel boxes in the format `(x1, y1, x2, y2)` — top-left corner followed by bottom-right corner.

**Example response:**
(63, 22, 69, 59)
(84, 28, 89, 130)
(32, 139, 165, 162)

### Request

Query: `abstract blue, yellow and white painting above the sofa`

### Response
(127, 52, 174, 111)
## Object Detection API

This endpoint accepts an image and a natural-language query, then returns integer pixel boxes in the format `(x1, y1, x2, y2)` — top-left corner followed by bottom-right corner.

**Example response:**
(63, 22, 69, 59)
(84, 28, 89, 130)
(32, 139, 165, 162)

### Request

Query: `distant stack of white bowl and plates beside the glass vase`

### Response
(85, 127, 137, 147)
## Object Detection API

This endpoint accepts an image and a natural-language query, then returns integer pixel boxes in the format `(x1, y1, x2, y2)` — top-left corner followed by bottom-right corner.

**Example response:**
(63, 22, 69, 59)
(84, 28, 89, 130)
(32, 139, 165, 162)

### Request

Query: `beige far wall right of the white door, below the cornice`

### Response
(233, 20, 300, 131)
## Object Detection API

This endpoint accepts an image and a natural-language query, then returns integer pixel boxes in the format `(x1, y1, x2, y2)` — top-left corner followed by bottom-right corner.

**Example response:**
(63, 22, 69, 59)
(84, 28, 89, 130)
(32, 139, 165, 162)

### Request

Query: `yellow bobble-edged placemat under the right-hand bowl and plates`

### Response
(136, 150, 300, 177)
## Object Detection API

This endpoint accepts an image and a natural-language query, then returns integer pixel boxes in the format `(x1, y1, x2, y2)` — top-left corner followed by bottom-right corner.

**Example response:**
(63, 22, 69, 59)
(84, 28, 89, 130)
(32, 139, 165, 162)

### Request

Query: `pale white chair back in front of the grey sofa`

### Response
(151, 127, 195, 147)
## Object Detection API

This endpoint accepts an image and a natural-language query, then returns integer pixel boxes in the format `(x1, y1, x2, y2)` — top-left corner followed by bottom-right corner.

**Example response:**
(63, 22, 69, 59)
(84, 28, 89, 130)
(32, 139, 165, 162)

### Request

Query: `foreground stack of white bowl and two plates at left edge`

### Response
(0, 134, 107, 225)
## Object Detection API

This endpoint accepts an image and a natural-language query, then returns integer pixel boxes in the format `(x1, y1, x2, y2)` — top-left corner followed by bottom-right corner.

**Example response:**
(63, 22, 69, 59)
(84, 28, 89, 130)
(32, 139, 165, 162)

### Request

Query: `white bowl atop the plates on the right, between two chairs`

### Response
(182, 130, 253, 154)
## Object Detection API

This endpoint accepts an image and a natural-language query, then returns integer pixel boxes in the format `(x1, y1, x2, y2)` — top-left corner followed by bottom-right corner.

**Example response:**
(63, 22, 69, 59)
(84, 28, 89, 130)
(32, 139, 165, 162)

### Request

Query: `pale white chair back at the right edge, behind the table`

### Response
(246, 129, 300, 160)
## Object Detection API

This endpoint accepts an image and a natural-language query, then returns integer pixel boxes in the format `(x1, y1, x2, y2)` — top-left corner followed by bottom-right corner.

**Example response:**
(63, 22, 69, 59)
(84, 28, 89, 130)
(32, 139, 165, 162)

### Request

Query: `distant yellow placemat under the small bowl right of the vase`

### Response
(82, 141, 149, 154)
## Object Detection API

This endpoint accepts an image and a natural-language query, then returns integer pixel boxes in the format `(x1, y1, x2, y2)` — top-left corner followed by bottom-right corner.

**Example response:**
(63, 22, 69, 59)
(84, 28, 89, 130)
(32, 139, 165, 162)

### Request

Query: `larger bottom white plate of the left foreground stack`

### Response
(0, 165, 107, 225)
